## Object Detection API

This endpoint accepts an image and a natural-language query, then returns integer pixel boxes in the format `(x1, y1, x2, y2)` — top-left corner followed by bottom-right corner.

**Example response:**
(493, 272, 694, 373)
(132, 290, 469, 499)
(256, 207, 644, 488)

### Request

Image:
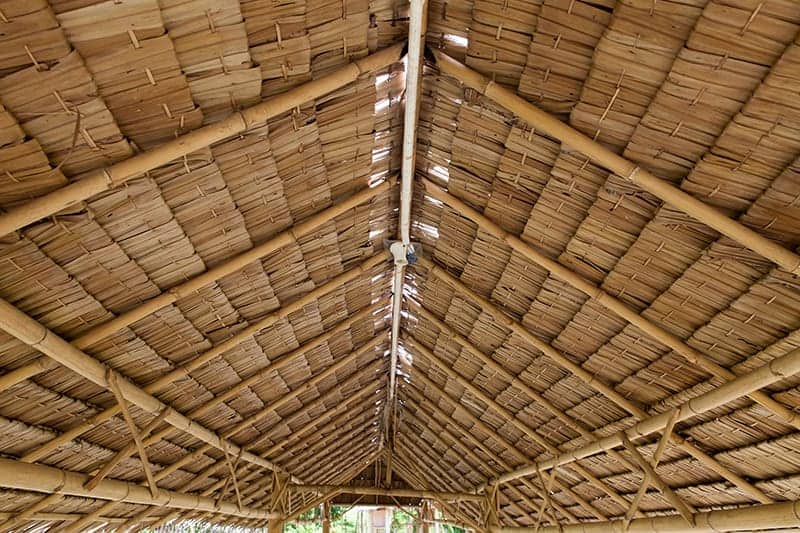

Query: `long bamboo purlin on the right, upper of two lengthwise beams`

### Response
(497, 342, 800, 483)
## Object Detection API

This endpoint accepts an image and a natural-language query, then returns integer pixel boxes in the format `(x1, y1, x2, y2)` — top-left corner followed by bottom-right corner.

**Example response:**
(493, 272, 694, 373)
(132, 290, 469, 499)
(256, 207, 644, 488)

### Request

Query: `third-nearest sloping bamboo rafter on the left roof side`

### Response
(22, 254, 386, 462)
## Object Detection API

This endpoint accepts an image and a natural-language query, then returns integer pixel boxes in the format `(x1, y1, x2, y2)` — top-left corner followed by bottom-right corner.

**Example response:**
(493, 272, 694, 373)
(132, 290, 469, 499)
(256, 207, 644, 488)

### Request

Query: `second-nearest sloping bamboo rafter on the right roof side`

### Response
(423, 179, 800, 429)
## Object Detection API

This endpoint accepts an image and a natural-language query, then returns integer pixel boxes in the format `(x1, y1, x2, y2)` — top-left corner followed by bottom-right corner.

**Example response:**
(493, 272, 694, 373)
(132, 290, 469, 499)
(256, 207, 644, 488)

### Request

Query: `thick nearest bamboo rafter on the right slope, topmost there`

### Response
(432, 50, 800, 275)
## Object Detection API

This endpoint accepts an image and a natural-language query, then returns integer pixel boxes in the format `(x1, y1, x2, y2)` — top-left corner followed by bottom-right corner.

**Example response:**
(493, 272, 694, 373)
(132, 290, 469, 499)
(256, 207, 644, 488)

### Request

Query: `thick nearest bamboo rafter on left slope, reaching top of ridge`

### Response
(0, 43, 405, 236)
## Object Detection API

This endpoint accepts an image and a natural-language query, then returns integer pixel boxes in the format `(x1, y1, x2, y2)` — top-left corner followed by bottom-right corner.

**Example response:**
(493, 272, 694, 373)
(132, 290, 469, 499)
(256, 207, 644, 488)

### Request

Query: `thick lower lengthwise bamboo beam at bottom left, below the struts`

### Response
(0, 459, 275, 520)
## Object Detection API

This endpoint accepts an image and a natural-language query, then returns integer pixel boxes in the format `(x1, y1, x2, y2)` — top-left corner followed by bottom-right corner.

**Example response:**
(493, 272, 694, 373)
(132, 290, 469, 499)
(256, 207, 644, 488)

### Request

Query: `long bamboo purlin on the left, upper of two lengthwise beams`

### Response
(0, 294, 290, 476)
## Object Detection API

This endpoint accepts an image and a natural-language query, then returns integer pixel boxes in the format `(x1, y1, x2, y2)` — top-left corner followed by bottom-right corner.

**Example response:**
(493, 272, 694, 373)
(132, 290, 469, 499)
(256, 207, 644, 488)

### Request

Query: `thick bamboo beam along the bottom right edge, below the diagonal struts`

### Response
(492, 501, 800, 533)
